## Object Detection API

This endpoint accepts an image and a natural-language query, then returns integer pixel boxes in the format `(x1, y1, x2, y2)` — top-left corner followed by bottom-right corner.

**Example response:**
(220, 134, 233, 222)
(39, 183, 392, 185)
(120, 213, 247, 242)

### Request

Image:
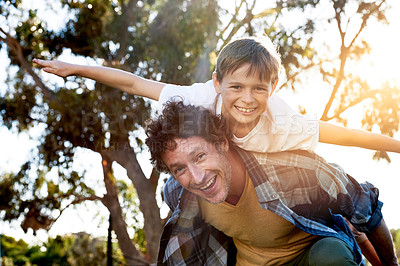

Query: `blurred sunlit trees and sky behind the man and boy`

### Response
(0, 0, 400, 265)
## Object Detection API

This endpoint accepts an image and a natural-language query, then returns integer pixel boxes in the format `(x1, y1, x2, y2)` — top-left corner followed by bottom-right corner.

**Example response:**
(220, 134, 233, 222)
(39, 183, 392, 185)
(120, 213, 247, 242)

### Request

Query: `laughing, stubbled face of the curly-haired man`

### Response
(161, 137, 232, 204)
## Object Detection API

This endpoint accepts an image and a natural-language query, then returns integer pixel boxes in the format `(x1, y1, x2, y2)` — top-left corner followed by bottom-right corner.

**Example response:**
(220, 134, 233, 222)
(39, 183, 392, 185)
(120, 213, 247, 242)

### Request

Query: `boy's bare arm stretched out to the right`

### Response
(319, 121, 400, 153)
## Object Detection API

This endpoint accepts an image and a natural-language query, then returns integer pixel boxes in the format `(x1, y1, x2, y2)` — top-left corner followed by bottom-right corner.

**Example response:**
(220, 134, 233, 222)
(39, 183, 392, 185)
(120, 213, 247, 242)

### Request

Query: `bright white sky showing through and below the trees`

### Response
(0, 0, 400, 243)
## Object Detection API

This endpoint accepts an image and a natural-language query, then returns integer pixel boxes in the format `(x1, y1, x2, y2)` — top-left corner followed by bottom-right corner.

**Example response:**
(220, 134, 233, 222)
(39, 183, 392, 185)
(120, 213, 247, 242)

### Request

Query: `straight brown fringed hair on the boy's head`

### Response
(215, 36, 281, 83)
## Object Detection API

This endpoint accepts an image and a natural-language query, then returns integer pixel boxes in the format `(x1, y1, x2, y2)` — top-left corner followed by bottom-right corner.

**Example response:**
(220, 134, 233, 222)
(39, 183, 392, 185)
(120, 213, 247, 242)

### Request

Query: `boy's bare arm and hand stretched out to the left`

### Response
(33, 59, 166, 100)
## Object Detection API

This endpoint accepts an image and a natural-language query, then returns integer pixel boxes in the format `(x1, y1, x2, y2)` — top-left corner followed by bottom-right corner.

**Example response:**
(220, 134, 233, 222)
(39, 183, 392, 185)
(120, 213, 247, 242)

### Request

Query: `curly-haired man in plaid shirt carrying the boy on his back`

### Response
(146, 102, 397, 265)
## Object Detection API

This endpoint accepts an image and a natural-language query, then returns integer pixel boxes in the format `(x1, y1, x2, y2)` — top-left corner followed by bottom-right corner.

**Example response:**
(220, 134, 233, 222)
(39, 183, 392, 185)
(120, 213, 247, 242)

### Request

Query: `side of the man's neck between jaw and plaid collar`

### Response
(225, 147, 246, 205)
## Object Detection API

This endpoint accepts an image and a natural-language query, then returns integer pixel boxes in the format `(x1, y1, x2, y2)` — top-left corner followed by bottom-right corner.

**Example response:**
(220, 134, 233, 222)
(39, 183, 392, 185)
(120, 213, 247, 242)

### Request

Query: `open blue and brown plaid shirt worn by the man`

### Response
(158, 148, 382, 265)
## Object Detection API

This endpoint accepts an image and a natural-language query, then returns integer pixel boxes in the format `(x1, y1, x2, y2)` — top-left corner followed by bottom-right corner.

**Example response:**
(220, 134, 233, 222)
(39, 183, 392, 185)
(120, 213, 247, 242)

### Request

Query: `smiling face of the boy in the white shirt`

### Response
(213, 64, 277, 137)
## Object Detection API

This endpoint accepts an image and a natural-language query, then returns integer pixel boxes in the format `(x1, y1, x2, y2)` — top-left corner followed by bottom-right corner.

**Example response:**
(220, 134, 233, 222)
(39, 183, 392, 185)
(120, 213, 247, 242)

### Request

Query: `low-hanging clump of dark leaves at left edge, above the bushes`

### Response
(0, 162, 94, 232)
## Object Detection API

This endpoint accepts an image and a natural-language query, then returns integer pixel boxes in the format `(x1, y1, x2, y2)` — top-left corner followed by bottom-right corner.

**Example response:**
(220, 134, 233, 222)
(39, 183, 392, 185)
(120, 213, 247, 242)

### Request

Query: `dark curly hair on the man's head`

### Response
(146, 99, 232, 172)
